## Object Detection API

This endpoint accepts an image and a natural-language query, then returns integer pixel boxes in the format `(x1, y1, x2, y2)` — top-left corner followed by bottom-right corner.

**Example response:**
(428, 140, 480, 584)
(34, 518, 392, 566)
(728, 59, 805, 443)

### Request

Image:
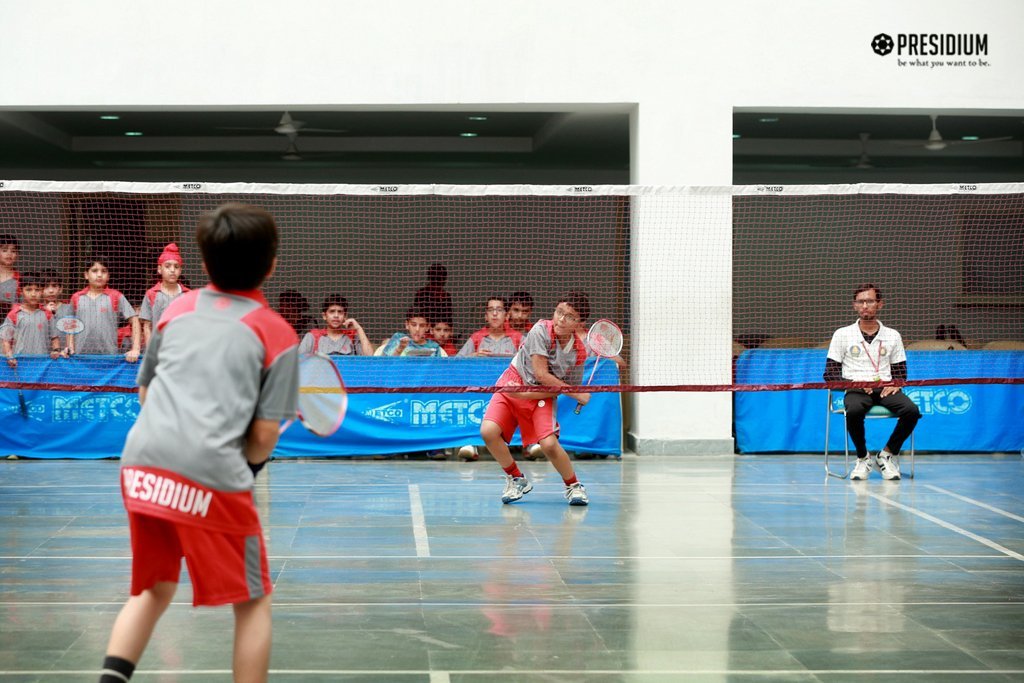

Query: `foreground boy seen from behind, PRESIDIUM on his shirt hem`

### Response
(100, 204, 298, 683)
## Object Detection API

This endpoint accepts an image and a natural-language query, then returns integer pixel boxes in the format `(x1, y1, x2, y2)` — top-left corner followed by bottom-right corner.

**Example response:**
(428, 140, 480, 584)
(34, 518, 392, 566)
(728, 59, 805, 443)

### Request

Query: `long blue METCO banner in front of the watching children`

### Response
(0, 356, 622, 458)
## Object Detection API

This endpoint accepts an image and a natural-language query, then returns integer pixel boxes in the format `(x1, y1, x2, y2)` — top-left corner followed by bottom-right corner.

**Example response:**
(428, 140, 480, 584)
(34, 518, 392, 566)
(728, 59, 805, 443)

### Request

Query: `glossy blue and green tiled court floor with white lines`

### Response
(0, 456, 1024, 683)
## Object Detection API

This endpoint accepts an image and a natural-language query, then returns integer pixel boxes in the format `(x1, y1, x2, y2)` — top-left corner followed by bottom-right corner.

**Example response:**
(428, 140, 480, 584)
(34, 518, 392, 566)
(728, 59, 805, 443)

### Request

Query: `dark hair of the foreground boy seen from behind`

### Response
(196, 203, 278, 290)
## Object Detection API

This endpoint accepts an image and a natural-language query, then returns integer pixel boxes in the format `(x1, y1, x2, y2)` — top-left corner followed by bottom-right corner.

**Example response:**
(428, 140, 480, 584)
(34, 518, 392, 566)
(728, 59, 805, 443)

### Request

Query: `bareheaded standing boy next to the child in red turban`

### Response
(69, 258, 141, 362)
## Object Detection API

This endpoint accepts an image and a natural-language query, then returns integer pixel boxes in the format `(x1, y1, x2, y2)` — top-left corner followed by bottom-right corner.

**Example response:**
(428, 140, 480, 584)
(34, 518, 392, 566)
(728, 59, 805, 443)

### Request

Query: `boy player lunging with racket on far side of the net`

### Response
(480, 291, 590, 505)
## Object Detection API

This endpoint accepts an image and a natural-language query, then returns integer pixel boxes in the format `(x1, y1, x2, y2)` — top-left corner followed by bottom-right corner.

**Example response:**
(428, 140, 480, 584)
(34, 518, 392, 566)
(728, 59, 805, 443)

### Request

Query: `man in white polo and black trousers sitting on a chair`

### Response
(824, 284, 921, 479)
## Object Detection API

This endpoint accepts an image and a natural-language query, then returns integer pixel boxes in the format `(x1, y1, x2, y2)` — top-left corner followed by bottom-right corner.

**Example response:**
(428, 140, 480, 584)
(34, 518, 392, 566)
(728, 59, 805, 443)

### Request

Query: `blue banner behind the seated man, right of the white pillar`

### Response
(734, 349, 1024, 453)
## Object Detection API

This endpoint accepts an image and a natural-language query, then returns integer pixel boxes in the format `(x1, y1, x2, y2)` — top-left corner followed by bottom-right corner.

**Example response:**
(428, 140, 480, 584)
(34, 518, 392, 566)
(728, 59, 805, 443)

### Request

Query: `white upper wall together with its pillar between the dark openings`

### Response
(0, 0, 1024, 450)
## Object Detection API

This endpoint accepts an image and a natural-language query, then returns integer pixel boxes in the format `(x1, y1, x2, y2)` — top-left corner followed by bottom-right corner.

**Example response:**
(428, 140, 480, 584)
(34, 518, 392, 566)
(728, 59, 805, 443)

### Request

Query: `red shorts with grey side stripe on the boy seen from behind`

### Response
(128, 510, 272, 606)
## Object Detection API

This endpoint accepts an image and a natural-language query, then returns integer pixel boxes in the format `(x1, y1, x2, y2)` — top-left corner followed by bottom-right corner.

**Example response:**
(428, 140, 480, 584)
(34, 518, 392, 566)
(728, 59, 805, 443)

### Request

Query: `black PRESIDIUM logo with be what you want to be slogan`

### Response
(871, 33, 991, 69)
